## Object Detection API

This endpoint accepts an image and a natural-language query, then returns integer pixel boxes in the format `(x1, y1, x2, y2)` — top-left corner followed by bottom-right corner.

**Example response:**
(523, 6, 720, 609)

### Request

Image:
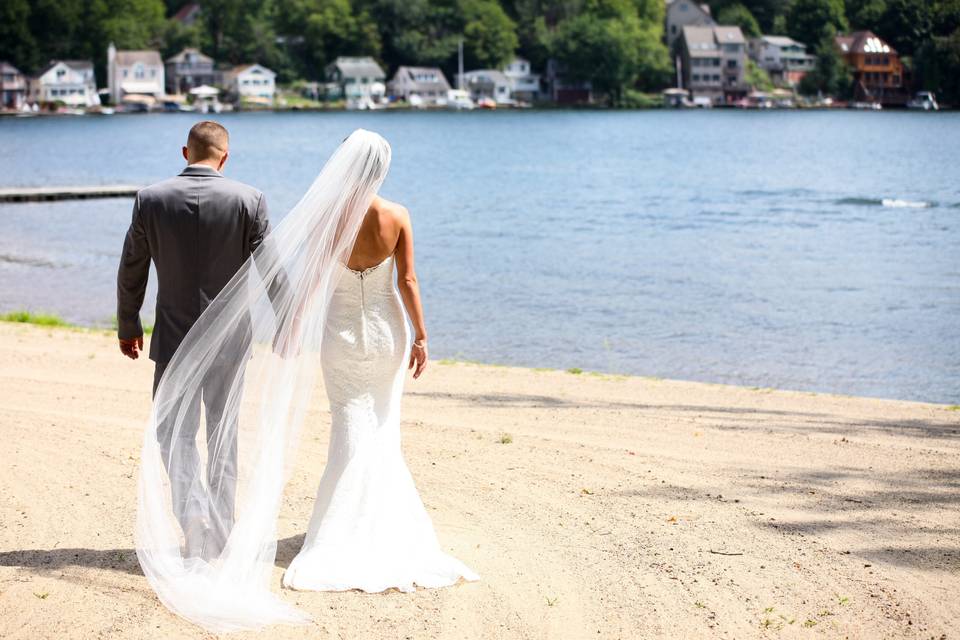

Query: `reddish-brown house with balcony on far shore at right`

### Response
(835, 31, 907, 106)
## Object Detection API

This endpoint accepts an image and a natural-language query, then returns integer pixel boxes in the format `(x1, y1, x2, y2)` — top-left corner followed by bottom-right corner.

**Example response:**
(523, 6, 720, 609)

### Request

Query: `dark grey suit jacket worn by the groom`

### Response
(117, 165, 270, 362)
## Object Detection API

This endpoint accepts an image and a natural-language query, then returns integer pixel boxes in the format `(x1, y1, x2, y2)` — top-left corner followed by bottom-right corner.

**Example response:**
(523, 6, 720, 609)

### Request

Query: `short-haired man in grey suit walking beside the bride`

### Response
(117, 121, 270, 558)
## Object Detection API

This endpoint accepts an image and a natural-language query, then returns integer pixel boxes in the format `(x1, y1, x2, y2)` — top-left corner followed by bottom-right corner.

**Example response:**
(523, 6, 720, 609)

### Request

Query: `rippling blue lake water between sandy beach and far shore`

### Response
(0, 110, 960, 402)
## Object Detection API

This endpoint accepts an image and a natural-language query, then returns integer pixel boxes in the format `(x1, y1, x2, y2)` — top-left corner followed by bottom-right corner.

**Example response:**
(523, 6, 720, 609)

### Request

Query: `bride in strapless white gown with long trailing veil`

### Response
(136, 130, 479, 632)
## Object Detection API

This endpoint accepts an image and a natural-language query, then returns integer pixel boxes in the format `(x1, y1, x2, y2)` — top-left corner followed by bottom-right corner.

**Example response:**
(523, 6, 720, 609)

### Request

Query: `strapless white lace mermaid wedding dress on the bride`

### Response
(283, 256, 479, 592)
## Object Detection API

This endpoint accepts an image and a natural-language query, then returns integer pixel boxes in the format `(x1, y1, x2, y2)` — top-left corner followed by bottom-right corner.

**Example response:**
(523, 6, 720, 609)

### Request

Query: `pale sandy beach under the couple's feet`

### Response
(0, 323, 960, 640)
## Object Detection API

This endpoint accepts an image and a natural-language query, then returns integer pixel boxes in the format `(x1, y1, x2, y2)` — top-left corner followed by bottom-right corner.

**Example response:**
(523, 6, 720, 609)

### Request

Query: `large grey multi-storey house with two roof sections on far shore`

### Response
(678, 25, 749, 105)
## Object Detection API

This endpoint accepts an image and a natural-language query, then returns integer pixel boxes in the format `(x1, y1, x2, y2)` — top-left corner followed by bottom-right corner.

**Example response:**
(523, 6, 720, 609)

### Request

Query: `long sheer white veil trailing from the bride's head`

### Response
(136, 129, 391, 632)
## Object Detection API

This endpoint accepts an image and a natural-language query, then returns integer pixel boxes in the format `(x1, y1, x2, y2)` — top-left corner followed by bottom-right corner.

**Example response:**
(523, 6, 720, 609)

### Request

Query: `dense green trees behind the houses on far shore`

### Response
(0, 0, 960, 104)
